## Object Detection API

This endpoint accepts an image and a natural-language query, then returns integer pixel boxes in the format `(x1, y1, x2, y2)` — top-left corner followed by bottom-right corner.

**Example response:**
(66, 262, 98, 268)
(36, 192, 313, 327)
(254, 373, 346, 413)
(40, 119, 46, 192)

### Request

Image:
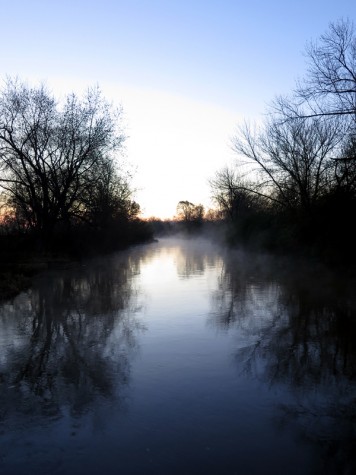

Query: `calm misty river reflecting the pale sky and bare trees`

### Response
(0, 240, 356, 475)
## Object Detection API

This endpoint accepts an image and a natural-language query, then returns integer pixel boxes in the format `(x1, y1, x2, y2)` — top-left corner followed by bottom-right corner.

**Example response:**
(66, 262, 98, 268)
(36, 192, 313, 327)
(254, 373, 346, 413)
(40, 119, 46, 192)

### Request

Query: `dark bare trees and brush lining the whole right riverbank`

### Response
(210, 20, 356, 263)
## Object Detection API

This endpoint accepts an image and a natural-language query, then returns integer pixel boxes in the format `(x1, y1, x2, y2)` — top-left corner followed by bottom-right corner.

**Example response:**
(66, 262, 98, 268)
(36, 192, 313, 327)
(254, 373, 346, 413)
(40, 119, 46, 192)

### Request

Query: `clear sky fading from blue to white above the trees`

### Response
(0, 0, 356, 219)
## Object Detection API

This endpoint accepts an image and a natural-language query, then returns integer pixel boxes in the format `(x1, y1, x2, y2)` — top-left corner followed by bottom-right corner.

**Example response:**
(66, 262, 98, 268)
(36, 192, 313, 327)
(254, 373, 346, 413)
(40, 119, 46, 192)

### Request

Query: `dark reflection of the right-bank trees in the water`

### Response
(213, 253, 356, 474)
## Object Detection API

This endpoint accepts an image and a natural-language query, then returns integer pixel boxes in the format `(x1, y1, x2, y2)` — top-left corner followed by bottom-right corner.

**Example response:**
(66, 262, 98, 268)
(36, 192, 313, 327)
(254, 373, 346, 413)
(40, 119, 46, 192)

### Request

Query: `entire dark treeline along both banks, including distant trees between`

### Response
(0, 19, 356, 298)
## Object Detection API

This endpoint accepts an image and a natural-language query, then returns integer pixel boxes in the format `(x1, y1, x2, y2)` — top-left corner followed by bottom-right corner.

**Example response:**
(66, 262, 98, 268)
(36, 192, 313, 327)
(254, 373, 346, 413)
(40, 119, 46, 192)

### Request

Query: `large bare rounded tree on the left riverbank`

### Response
(0, 79, 124, 241)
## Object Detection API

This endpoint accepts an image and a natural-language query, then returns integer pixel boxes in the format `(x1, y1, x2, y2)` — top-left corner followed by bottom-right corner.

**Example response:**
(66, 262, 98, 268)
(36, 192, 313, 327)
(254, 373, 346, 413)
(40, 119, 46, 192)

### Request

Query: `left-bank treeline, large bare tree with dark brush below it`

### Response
(0, 79, 150, 260)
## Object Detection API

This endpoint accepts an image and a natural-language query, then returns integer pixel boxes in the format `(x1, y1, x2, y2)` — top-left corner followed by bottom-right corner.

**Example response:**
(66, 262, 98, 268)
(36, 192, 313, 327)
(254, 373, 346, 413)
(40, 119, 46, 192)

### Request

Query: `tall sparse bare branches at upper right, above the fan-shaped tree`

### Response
(274, 20, 356, 127)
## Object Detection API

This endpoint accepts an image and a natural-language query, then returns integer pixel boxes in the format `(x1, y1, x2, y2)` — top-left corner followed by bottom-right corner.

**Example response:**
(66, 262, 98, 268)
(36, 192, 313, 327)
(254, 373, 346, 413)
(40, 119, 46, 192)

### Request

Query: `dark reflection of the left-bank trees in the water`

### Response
(0, 255, 145, 430)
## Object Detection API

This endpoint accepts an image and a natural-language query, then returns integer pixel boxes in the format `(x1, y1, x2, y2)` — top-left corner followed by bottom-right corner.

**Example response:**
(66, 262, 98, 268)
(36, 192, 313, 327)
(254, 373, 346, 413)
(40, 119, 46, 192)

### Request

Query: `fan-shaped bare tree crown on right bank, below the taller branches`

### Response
(234, 118, 341, 211)
